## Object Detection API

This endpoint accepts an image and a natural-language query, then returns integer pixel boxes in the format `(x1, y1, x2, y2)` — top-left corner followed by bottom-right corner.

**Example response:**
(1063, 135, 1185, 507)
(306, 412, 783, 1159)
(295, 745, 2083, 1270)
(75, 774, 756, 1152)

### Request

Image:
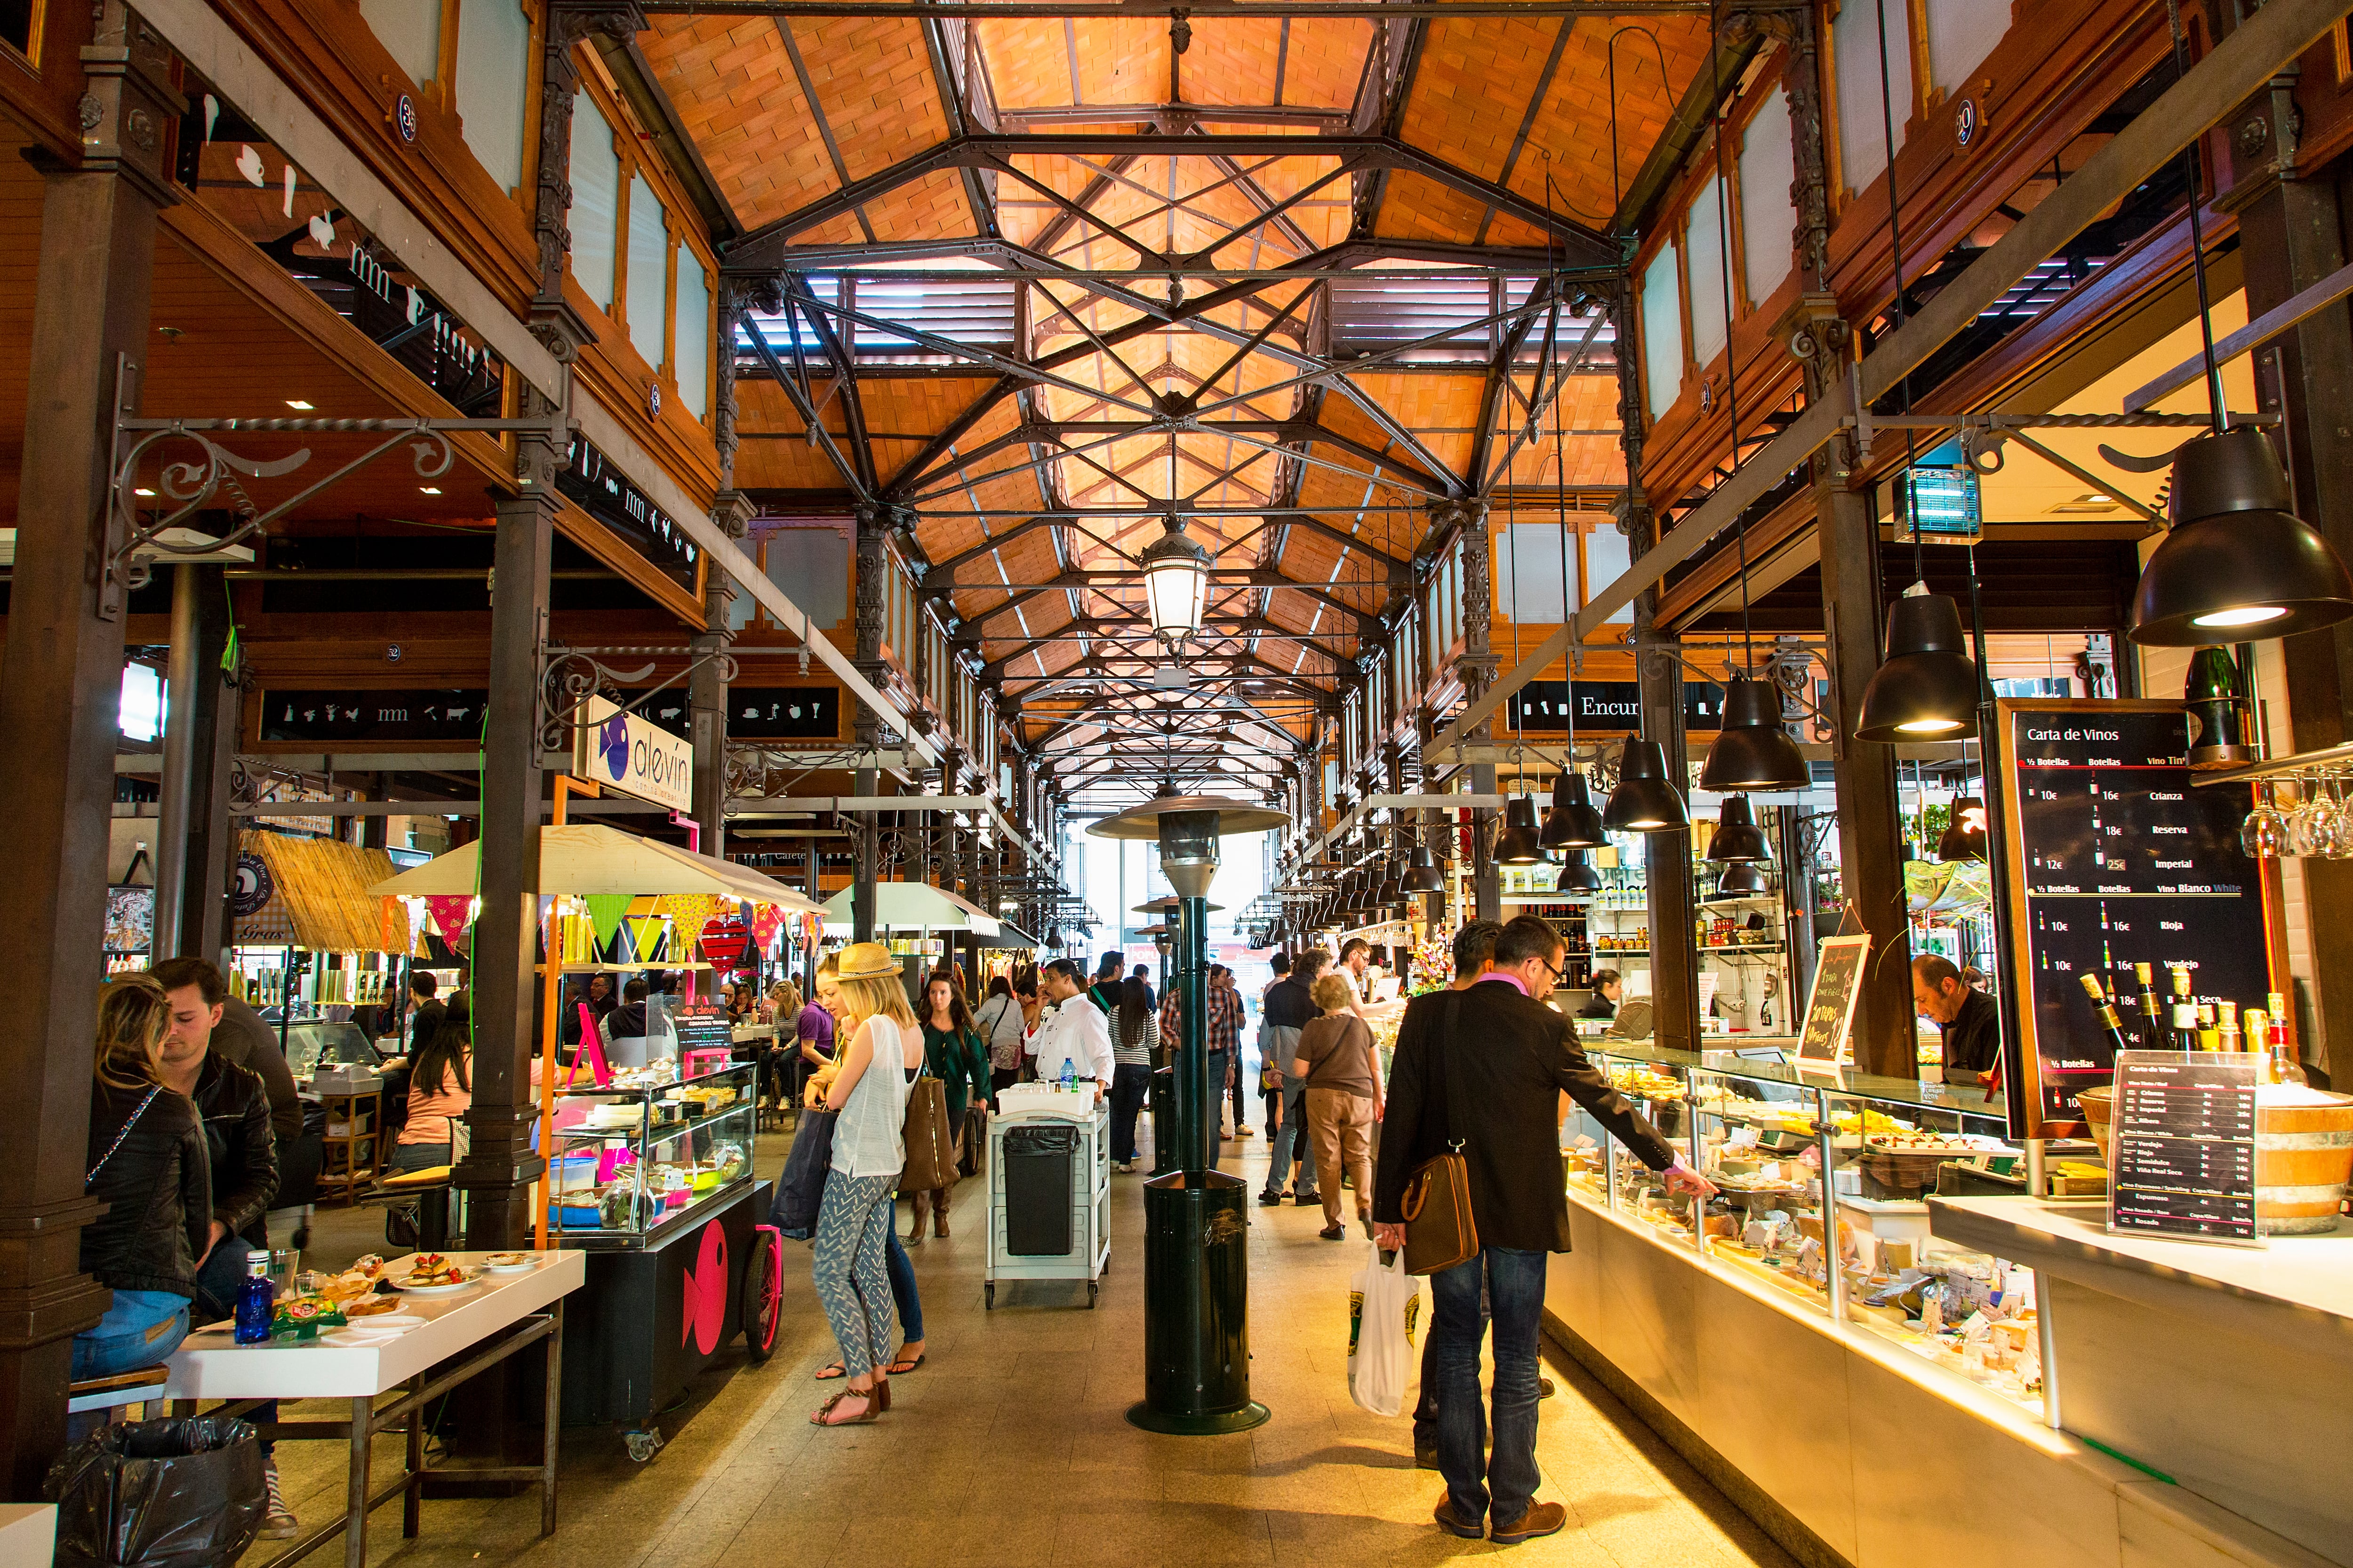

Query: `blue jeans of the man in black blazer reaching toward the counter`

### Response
(1431, 1248, 1546, 1526)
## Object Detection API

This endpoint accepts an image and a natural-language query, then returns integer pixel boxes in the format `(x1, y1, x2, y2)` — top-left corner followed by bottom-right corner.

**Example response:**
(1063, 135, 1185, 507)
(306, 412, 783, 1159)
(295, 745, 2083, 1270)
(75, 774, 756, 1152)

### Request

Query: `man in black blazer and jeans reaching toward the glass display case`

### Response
(1372, 916, 1715, 1547)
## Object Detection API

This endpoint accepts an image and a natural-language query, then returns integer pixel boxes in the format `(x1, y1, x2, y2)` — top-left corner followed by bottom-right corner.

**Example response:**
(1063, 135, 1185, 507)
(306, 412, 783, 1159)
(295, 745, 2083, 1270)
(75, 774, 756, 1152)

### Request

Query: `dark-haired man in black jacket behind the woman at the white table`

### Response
(153, 958, 296, 1540)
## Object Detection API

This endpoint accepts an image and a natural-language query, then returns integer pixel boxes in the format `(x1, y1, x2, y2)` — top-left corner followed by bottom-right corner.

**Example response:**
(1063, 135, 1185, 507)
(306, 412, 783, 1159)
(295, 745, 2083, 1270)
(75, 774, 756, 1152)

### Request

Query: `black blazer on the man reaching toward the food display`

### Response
(1372, 979, 1675, 1253)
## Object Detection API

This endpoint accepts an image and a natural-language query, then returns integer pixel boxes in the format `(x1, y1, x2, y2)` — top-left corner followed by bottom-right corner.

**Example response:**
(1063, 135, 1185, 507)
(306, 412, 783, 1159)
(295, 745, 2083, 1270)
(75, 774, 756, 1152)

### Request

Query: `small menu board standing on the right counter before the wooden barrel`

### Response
(2108, 1050, 2264, 1246)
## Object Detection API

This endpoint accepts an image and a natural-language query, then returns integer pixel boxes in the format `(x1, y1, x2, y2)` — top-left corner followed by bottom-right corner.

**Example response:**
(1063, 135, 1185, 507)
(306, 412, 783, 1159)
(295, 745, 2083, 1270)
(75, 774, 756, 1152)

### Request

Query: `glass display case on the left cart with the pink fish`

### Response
(548, 1057, 760, 1248)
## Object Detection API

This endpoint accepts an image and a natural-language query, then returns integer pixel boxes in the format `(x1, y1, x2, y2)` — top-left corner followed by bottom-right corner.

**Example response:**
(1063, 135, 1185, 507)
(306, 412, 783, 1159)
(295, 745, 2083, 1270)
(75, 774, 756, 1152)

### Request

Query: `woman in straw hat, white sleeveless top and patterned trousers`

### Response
(809, 942, 922, 1427)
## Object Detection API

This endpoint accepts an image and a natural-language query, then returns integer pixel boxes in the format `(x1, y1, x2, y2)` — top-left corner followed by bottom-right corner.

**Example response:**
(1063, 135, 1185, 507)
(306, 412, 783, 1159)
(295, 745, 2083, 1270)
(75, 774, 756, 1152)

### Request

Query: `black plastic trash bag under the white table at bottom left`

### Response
(40, 1415, 264, 1568)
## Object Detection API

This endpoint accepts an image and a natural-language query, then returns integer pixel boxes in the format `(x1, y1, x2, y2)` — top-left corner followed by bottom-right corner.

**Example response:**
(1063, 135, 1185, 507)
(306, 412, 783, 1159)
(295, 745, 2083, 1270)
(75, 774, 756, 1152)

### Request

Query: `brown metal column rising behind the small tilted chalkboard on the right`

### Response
(1814, 480, 1920, 1078)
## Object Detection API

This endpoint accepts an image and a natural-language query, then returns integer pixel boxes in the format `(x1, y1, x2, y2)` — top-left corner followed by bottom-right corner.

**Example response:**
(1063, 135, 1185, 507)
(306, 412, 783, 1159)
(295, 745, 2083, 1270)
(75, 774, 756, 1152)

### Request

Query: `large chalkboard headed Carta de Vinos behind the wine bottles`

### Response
(1998, 697, 2278, 1137)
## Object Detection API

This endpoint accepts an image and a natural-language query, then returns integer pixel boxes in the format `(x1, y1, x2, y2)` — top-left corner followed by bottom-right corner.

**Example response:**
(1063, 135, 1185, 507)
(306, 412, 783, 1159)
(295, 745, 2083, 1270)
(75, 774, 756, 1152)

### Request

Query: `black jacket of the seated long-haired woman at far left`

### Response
(82, 1083, 212, 1300)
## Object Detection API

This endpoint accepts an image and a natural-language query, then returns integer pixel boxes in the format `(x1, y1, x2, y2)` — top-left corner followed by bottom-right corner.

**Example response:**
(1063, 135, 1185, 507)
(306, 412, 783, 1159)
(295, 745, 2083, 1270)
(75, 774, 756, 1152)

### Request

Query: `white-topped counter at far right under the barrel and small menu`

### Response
(1929, 1199, 2353, 1563)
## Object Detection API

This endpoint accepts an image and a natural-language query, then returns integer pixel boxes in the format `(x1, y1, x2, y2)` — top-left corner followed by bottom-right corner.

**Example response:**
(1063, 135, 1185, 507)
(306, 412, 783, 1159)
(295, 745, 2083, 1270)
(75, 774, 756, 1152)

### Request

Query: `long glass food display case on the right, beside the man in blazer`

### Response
(1562, 1040, 2042, 1410)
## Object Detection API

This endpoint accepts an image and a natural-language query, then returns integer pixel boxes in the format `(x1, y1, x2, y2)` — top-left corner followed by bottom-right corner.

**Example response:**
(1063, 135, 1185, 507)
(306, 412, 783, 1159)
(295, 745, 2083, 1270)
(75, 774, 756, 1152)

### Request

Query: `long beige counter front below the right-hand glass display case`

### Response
(1544, 1189, 2353, 1568)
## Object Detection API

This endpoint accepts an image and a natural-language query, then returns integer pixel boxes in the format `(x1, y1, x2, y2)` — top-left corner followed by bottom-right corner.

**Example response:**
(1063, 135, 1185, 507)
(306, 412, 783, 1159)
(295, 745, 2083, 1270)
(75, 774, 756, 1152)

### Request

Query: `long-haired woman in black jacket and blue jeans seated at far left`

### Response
(73, 975, 212, 1382)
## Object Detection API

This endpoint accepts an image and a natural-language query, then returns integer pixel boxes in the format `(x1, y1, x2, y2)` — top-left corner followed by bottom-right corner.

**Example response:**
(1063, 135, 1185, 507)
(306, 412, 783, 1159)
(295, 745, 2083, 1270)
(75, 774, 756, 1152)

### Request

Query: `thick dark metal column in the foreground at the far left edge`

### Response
(0, 0, 181, 1500)
